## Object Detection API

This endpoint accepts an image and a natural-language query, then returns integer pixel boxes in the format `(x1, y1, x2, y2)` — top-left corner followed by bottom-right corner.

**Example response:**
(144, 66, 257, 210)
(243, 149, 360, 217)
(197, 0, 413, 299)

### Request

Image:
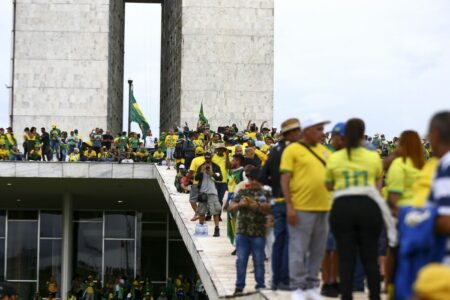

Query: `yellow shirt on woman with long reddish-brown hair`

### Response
(386, 157, 420, 206)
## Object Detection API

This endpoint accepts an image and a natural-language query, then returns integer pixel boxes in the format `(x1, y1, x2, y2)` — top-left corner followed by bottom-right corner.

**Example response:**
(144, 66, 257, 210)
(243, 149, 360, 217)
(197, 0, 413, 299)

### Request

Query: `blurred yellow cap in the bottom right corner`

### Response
(414, 264, 450, 300)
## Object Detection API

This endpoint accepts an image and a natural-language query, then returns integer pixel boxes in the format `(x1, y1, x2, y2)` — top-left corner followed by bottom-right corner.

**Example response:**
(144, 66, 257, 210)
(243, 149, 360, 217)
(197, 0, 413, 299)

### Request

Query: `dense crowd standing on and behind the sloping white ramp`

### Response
(168, 112, 450, 300)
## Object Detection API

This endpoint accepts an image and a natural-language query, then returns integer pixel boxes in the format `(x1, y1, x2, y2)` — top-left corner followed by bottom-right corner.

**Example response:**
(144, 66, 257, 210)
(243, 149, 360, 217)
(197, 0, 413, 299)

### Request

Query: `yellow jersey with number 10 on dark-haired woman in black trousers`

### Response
(326, 147, 383, 190)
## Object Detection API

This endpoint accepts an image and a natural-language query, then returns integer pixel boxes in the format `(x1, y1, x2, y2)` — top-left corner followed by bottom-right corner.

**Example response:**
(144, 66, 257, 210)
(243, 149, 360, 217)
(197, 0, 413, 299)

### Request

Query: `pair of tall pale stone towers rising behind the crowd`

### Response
(10, 0, 274, 139)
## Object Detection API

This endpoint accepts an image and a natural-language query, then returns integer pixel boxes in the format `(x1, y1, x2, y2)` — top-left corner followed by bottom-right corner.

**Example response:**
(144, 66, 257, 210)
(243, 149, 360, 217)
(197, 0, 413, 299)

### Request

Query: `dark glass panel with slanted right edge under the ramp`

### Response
(169, 242, 197, 278)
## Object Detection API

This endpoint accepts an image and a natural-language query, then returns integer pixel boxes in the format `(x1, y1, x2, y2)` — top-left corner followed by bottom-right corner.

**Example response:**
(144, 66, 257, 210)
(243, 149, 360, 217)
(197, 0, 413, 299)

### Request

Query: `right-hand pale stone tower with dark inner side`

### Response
(161, 0, 274, 130)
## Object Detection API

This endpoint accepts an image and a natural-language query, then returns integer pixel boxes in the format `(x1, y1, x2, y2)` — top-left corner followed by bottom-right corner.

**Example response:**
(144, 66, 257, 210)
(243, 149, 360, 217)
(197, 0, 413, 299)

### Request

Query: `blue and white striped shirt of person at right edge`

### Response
(428, 152, 450, 265)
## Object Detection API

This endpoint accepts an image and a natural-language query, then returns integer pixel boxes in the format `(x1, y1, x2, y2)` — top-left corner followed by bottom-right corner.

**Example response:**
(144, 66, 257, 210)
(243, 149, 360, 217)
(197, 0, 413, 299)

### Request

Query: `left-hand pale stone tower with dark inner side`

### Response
(12, 0, 124, 143)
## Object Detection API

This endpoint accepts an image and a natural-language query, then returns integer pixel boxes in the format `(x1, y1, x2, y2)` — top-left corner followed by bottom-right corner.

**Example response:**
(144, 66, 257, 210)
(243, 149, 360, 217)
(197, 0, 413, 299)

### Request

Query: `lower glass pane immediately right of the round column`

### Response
(72, 222, 103, 278)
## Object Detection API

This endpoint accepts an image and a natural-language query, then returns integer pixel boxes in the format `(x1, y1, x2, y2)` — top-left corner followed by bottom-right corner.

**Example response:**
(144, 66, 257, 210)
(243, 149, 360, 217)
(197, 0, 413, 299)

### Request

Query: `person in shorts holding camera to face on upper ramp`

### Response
(195, 151, 222, 237)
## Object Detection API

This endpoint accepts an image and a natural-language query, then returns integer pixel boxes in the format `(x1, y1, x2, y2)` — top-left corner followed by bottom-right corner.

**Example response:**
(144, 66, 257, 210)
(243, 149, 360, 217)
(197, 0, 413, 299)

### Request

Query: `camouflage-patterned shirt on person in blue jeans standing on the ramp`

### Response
(233, 186, 272, 237)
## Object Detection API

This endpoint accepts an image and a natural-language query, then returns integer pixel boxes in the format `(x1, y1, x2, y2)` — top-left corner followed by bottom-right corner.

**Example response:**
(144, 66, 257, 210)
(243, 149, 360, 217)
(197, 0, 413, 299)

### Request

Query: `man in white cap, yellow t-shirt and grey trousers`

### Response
(280, 115, 331, 299)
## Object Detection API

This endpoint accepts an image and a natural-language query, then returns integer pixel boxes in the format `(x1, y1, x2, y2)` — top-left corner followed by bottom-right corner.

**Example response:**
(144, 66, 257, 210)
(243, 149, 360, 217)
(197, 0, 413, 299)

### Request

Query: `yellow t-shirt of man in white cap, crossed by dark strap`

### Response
(280, 143, 331, 212)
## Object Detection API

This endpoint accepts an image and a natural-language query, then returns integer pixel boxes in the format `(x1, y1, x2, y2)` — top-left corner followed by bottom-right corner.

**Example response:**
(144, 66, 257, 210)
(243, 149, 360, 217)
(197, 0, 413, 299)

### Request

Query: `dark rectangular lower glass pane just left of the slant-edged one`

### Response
(141, 223, 167, 281)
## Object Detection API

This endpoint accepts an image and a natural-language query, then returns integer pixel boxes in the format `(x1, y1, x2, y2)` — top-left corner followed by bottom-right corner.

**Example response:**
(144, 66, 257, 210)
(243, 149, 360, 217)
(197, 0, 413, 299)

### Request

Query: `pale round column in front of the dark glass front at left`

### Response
(61, 193, 73, 299)
